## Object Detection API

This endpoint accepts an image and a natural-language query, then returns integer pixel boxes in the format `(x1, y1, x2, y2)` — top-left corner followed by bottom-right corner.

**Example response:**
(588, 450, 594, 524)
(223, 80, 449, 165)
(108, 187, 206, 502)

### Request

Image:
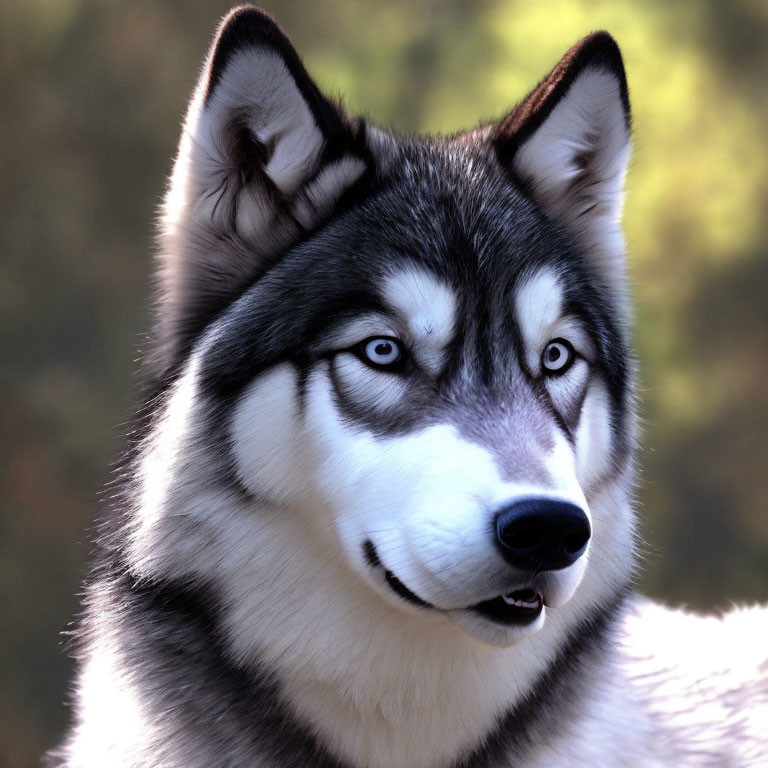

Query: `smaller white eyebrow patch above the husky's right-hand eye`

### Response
(515, 268, 563, 367)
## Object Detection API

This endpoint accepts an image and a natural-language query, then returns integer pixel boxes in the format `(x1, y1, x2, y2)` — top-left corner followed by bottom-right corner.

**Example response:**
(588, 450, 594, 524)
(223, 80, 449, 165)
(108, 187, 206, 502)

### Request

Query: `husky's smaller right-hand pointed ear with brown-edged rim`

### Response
(494, 32, 630, 304)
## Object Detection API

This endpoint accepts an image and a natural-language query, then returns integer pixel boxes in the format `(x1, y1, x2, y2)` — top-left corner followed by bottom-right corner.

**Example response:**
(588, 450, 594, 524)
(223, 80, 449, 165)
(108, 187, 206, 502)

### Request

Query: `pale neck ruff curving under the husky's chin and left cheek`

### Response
(123, 390, 632, 768)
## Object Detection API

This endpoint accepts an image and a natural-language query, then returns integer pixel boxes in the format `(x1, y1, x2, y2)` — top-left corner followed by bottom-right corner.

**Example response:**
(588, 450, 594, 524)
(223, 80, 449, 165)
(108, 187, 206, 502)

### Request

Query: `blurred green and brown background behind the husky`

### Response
(0, 0, 768, 768)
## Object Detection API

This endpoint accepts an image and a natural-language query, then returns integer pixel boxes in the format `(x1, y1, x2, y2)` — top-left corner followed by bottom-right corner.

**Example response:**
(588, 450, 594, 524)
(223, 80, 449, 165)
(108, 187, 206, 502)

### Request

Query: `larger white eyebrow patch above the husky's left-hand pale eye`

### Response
(383, 267, 456, 374)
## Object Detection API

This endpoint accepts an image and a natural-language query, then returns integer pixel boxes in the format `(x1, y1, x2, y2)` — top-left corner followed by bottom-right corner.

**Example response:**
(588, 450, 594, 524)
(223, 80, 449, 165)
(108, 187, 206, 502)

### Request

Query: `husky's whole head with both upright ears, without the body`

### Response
(129, 8, 633, 651)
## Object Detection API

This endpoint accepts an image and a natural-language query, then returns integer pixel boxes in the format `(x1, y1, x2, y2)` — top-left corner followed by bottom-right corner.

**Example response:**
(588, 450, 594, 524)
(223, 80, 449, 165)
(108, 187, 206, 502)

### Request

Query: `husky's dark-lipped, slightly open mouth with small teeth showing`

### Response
(363, 540, 544, 627)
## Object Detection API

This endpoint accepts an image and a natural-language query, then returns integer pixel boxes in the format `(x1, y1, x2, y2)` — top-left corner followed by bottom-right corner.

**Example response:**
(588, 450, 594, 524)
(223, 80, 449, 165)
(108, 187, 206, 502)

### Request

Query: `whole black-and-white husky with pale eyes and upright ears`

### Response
(49, 7, 768, 768)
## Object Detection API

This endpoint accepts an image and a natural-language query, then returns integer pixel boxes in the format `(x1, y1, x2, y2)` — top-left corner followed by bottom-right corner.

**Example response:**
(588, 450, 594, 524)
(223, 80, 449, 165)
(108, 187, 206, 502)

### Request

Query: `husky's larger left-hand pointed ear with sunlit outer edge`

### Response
(155, 7, 372, 371)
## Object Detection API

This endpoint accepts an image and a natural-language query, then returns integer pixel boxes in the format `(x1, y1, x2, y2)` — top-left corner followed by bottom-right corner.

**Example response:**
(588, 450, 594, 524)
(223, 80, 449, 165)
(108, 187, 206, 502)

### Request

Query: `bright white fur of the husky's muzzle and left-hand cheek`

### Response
(231, 362, 588, 608)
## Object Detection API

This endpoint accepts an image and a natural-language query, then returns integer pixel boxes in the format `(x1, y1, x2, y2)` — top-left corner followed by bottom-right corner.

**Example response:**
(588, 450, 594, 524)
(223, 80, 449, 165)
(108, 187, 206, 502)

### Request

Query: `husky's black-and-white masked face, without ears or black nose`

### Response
(212, 176, 626, 644)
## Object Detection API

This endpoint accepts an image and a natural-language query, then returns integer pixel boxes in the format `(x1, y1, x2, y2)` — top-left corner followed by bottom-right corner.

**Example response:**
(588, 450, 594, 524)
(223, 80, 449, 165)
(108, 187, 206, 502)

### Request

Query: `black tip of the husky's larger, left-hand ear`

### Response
(205, 5, 293, 101)
